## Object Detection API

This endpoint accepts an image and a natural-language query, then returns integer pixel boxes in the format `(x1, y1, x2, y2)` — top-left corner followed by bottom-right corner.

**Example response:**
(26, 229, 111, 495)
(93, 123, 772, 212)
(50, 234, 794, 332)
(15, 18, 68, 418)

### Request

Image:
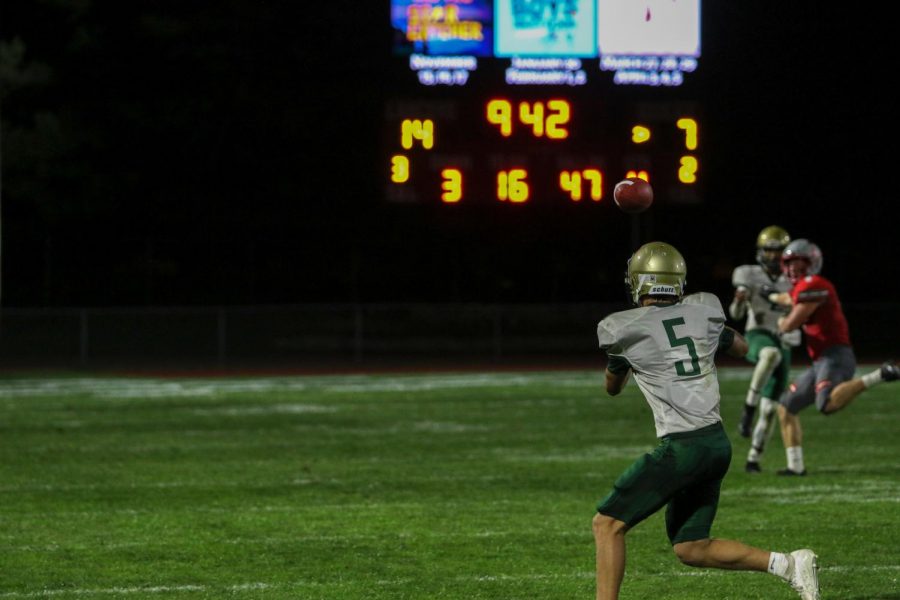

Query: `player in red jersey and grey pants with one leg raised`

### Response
(771, 239, 900, 475)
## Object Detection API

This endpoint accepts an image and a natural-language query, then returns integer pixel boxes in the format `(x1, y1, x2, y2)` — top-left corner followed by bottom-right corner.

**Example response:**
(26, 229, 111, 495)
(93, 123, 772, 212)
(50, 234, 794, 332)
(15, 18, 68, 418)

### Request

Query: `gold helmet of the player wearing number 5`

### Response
(625, 242, 687, 305)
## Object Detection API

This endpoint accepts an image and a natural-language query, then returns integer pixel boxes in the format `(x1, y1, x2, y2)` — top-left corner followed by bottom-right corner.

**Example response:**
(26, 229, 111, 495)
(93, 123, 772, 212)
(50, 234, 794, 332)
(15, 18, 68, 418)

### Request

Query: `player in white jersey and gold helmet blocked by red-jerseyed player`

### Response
(728, 225, 800, 473)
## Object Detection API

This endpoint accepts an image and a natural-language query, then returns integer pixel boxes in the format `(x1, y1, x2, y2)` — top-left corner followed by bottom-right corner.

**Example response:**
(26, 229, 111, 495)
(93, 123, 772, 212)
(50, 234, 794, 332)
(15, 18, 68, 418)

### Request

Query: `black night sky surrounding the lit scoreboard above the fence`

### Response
(0, 0, 898, 307)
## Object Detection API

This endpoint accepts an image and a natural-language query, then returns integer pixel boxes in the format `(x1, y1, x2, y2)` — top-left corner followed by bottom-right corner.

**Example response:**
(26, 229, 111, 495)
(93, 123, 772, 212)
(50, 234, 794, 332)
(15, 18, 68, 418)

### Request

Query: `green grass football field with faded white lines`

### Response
(0, 368, 900, 600)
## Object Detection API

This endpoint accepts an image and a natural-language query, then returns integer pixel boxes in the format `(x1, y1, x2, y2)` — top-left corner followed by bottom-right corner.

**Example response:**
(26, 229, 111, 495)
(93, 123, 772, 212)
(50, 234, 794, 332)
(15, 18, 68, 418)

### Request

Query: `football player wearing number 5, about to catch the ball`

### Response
(593, 242, 819, 600)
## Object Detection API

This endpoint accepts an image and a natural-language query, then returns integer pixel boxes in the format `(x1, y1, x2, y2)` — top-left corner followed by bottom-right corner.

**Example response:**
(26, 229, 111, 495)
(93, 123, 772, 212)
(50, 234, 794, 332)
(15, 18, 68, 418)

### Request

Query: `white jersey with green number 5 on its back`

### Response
(597, 292, 725, 437)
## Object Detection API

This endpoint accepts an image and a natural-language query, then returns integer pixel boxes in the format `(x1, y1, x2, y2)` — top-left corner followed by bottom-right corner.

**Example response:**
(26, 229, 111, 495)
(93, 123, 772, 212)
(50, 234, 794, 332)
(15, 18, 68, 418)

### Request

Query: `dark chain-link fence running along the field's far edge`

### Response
(0, 303, 898, 368)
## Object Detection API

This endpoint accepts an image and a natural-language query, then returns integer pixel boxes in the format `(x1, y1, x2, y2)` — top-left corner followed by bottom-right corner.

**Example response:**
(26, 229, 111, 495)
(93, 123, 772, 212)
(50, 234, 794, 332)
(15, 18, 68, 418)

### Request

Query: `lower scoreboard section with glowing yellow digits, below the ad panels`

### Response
(382, 101, 703, 210)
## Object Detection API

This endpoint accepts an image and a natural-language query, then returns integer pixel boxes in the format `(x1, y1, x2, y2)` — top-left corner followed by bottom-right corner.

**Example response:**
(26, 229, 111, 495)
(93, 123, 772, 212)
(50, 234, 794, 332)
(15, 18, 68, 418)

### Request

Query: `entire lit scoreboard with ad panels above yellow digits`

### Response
(383, 0, 704, 206)
